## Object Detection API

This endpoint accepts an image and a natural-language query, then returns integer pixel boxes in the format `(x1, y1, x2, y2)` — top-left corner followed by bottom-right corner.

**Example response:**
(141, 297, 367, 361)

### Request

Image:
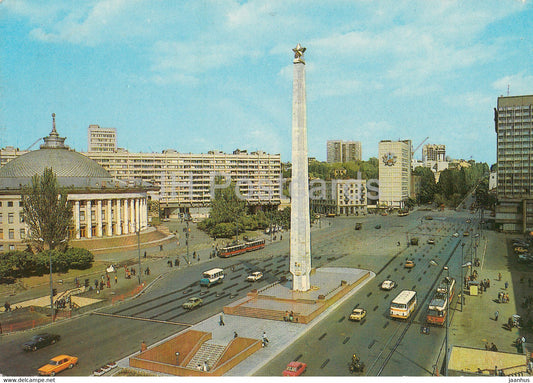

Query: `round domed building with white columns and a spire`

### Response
(0, 114, 150, 251)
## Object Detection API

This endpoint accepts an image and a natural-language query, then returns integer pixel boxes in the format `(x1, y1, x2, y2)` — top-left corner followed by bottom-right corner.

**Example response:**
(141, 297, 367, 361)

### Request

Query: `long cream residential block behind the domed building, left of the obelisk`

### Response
(84, 149, 282, 217)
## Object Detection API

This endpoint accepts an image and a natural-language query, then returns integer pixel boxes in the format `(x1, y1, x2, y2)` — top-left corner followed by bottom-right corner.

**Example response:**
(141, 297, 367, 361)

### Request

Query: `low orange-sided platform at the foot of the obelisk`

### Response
(224, 267, 374, 323)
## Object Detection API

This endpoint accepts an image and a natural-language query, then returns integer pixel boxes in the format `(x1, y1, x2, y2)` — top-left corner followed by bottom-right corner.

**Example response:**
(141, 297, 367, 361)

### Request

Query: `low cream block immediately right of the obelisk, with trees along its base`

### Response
(309, 179, 368, 215)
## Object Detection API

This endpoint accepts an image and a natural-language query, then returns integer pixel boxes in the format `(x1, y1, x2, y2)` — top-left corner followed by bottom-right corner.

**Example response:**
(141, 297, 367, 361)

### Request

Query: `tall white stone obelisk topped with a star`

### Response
(290, 44, 311, 291)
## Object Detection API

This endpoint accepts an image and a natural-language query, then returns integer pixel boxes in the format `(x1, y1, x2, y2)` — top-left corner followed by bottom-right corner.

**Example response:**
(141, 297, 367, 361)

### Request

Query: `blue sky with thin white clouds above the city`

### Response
(0, 0, 533, 165)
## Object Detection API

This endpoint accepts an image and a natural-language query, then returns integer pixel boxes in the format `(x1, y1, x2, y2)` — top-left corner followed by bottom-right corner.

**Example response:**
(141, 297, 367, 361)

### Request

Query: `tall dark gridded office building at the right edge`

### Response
(494, 95, 533, 232)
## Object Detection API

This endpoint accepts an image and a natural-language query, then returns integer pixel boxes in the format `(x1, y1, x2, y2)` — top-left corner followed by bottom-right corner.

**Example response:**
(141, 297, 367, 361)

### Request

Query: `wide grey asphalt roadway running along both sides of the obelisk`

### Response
(0, 207, 480, 376)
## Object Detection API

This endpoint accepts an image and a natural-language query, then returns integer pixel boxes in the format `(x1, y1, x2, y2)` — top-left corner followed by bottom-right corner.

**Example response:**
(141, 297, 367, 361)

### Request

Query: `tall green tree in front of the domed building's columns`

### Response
(22, 168, 72, 251)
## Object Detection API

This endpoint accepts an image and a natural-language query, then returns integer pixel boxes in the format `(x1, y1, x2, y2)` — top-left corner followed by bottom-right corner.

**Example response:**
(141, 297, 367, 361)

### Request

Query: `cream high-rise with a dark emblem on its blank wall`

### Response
(378, 140, 412, 208)
